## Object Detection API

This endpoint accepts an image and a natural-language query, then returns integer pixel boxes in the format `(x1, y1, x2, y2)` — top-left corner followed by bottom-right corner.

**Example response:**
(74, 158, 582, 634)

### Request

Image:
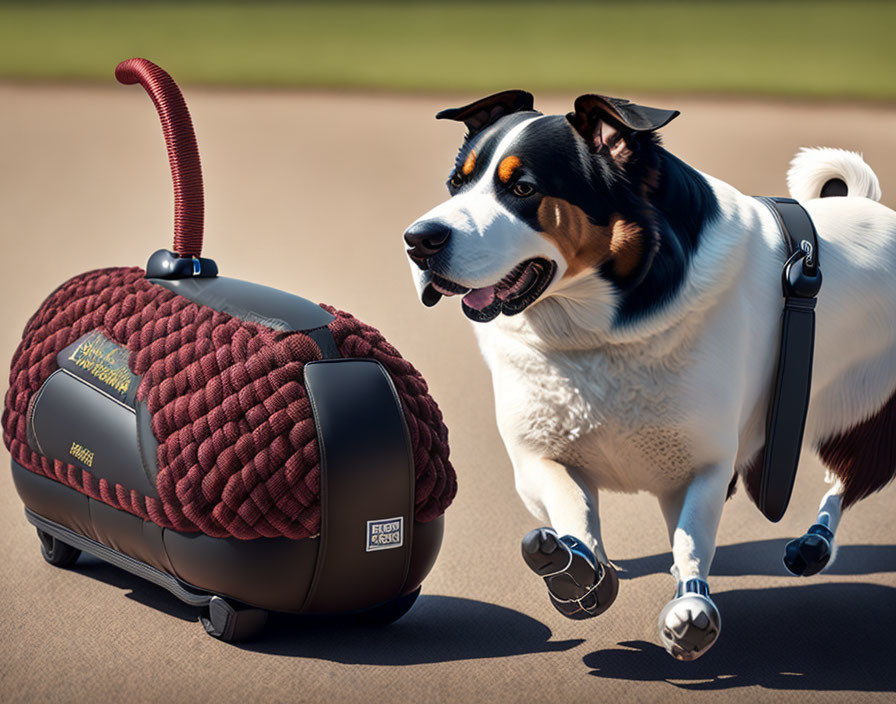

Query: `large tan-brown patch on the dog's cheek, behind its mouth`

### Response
(538, 196, 644, 278)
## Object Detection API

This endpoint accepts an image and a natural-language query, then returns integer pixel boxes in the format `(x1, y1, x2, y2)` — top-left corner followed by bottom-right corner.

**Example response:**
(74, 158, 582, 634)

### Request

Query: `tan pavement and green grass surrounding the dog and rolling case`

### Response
(0, 1, 896, 704)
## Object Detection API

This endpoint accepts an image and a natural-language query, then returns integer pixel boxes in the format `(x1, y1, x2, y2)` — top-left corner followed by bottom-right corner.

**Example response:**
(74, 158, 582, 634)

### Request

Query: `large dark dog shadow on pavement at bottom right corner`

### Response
(584, 582, 896, 692)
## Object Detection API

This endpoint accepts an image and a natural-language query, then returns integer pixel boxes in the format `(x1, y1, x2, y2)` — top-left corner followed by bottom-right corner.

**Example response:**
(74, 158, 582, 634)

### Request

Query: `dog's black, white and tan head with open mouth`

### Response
(404, 90, 678, 322)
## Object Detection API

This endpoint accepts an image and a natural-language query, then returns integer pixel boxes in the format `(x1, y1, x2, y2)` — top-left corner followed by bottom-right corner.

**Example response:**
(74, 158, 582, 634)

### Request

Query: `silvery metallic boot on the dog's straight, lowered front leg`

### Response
(659, 579, 722, 661)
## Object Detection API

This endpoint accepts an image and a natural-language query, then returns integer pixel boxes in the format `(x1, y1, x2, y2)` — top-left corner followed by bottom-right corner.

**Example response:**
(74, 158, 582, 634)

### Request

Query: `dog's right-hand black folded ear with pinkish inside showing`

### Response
(566, 93, 680, 158)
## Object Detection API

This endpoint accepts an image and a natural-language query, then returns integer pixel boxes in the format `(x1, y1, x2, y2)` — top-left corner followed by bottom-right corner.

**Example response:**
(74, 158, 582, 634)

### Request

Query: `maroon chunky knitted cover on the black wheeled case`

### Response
(3, 267, 457, 539)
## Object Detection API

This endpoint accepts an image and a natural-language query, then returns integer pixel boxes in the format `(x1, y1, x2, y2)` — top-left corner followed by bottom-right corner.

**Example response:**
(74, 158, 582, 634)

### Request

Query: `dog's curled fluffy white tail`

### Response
(787, 147, 880, 201)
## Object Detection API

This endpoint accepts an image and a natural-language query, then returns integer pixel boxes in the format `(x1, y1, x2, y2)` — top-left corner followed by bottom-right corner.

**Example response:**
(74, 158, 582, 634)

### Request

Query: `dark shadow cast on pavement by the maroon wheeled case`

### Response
(240, 594, 584, 665)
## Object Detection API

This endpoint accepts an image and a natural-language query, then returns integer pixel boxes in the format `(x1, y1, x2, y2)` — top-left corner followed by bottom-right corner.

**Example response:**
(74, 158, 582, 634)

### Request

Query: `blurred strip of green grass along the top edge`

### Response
(0, 0, 896, 101)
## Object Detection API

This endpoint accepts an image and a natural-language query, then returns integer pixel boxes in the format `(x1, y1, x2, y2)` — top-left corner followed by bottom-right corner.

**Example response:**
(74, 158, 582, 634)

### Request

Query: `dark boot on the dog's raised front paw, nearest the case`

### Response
(522, 528, 619, 619)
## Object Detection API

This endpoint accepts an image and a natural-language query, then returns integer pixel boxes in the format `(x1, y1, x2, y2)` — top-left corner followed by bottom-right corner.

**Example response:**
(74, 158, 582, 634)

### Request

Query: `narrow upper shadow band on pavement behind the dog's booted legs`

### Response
(613, 538, 896, 579)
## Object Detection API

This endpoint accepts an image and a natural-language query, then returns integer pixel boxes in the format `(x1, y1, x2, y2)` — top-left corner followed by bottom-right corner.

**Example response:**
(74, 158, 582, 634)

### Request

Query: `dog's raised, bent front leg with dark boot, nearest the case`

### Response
(514, 459, 619, 619)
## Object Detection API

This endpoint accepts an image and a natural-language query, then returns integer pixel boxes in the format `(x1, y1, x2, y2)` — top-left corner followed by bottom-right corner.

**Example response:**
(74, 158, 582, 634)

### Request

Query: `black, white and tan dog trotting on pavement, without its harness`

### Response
(404, 90, 896, 660)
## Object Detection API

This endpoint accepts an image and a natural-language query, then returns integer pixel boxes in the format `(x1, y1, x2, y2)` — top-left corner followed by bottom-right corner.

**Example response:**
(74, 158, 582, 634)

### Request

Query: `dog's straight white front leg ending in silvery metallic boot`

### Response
(659, 466, 731, 660)
